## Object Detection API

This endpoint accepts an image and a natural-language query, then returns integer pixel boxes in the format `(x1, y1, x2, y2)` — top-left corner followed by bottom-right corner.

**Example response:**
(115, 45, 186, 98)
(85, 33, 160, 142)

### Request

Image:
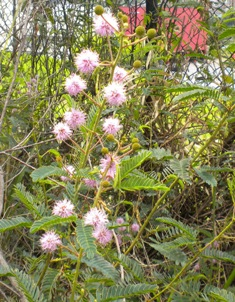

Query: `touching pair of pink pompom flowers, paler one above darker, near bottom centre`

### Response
(84, 208, 113, 246)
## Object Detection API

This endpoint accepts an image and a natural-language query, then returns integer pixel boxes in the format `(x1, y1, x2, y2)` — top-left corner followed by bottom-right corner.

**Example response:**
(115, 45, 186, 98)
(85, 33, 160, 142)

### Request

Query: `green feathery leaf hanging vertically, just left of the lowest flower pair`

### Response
(76, 219, 96, 259)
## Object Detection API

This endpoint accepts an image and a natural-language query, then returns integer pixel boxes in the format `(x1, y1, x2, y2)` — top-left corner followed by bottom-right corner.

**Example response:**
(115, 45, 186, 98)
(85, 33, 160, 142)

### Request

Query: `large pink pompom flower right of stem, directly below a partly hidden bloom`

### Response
(104, 82, 126, 106)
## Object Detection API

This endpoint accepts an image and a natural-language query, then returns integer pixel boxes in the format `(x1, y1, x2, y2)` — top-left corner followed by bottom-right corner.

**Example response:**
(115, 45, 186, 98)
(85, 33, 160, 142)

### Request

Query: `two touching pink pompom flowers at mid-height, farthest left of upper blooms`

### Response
(52, 108, 86, 141)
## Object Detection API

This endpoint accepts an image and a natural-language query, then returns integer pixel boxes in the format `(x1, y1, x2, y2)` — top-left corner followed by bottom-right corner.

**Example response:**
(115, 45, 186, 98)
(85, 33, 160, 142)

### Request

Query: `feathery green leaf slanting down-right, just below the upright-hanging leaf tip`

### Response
(82, 254, 120, 282)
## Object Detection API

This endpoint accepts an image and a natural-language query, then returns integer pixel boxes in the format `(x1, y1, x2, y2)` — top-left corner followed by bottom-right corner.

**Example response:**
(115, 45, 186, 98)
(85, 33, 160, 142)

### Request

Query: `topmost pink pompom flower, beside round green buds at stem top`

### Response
(93, 13, 119, 37)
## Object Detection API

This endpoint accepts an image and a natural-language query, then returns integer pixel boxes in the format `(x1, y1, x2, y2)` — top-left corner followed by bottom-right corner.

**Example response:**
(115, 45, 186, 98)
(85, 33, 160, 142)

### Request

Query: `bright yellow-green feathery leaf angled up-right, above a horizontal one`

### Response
(120, 150, 152, 179)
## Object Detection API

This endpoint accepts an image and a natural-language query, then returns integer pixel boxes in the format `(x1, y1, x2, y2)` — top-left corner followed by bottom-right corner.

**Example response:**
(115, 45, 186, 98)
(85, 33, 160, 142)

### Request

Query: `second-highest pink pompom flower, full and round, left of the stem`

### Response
(75, 49, 100, 74)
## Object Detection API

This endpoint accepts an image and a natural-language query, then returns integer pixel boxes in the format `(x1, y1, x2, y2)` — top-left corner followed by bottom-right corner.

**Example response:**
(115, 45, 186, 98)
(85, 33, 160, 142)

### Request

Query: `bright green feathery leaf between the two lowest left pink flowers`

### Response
(30, 216, 77, 234)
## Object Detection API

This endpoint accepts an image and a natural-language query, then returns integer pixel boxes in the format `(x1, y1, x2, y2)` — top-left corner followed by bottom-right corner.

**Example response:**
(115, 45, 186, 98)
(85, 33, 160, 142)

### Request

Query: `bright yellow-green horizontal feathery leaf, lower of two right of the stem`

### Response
(120, 176, 169, 191)
